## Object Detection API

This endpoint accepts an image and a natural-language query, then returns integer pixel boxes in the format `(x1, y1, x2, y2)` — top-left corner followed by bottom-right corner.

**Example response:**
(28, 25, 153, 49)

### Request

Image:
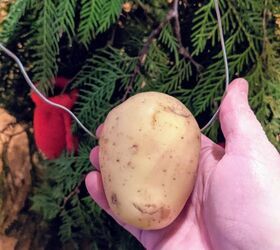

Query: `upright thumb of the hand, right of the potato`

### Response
(219, 78, 271, 155)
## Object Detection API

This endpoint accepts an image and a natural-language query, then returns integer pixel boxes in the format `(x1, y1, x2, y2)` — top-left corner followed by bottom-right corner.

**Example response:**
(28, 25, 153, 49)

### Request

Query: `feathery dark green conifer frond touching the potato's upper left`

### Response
(73, 47, 136, 131)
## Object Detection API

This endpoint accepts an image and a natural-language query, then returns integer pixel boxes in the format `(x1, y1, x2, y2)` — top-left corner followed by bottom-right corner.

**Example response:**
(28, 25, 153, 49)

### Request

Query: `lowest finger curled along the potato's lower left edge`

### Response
(85, 171, 140, 238)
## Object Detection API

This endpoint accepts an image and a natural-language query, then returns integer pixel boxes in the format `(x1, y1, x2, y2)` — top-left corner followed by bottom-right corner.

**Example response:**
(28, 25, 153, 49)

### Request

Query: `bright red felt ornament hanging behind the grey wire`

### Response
(31, 77, 78, 159)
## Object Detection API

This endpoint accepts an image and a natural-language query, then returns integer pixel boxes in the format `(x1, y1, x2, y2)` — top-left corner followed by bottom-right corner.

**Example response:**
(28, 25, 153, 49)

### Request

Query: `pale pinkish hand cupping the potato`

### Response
(86, 79, 280, 250)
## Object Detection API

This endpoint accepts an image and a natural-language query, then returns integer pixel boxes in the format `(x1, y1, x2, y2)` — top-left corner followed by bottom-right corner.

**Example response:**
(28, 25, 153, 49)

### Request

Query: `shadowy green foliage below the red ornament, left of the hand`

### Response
(31, 141, 141, 249)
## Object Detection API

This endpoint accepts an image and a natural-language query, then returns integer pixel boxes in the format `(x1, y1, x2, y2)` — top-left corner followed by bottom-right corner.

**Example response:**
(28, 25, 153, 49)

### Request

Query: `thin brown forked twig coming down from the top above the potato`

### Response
(122, 0, 203, 101)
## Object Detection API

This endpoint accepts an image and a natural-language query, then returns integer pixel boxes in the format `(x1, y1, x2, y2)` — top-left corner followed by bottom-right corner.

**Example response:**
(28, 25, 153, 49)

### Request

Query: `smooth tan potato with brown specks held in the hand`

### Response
(99, 92, 200, 229)
